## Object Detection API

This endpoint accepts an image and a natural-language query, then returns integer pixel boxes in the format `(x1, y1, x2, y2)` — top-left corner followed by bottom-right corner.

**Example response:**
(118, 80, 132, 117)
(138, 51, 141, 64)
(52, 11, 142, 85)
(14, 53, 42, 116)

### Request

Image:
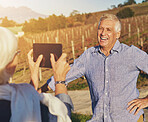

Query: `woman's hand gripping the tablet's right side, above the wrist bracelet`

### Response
(50, 53, 70, 81)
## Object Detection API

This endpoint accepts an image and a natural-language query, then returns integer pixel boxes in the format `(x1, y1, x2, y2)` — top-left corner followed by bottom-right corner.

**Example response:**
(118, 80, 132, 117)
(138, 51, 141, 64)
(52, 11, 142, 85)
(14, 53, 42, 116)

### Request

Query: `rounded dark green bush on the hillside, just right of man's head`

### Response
(116, 7, 134, 19)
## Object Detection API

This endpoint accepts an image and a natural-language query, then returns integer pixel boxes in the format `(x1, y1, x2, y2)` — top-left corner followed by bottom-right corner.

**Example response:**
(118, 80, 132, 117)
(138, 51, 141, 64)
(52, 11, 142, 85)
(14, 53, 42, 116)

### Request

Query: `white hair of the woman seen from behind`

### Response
(0, 27, 18, 84)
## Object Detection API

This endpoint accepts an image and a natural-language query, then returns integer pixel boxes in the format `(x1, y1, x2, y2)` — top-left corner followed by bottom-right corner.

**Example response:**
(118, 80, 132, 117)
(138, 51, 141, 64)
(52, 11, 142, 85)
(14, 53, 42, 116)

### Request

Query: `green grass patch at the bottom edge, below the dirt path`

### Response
(71, 113, 92, 122)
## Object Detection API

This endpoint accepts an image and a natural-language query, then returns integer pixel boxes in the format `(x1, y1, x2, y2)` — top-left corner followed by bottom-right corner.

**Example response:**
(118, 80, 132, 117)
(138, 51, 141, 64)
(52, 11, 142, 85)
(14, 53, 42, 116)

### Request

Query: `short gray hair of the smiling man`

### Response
(99, 14, 121, 32)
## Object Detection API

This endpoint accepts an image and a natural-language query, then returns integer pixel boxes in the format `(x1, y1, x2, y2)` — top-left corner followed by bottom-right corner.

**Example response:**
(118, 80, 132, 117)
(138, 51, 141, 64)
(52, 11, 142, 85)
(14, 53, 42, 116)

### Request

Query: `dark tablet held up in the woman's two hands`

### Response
(33, 43, 62, 68)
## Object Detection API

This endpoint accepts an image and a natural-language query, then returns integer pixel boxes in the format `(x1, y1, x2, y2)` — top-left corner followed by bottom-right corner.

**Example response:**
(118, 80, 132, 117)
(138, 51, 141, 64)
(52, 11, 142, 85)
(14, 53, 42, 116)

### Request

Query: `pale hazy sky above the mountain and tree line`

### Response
(0, 0, 142, 16)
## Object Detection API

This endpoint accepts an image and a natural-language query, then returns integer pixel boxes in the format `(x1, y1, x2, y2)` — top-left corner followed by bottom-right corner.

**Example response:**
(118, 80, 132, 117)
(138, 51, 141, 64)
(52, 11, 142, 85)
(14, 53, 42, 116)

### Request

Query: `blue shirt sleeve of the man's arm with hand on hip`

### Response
(134, 47, 148, 74)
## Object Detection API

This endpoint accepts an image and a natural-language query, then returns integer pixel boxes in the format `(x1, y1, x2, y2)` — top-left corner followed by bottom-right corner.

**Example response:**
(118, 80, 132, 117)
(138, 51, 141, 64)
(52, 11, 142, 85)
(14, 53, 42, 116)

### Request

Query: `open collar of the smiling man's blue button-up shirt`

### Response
(94, 40, 121, 53)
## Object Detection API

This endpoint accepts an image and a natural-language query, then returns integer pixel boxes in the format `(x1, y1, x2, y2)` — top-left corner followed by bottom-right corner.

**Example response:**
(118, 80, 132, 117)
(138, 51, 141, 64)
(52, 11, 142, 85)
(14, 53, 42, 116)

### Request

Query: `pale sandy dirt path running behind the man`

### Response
(68, 88, 148, 122)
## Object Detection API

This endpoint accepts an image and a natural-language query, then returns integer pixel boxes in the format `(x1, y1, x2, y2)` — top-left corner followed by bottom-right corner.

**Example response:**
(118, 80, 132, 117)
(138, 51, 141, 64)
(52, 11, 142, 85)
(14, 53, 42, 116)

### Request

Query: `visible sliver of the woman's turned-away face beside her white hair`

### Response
(6, 55, 18, 75)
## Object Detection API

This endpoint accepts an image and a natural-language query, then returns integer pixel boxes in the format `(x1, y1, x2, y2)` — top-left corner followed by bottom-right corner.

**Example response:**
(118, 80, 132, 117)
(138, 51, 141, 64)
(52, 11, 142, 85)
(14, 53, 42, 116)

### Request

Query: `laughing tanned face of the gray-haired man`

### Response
(98, 20, 120, 49)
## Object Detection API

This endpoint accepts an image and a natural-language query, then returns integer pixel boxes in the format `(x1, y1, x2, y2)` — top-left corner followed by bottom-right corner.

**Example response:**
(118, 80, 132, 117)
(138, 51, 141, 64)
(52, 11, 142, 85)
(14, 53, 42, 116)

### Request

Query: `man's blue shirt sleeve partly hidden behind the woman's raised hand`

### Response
(47, 49, 86, 91)
